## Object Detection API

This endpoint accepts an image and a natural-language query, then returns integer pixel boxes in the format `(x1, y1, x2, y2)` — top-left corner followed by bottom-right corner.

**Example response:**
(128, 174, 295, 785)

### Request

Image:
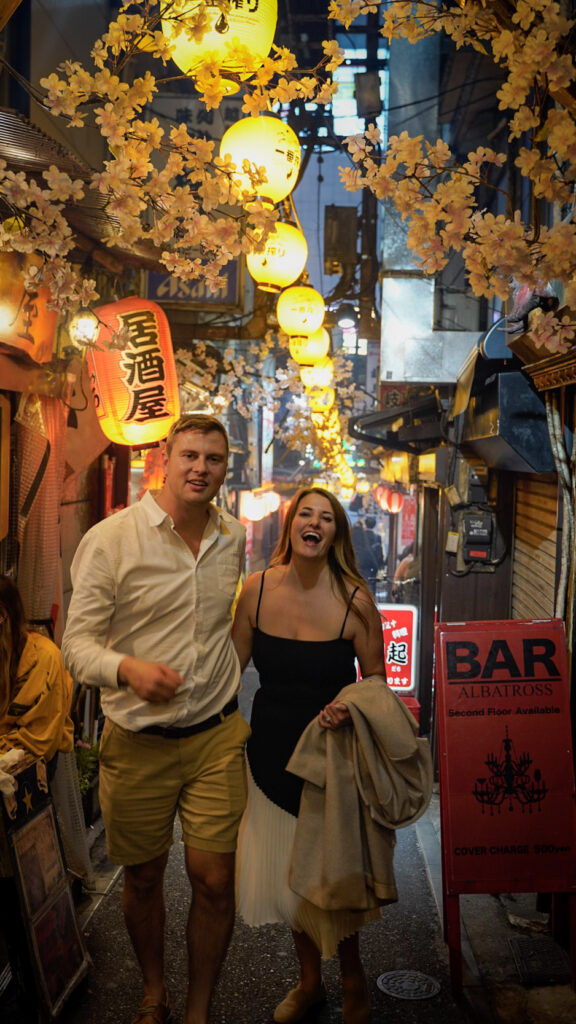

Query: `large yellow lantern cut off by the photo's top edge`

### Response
(162, 0, 278, 94)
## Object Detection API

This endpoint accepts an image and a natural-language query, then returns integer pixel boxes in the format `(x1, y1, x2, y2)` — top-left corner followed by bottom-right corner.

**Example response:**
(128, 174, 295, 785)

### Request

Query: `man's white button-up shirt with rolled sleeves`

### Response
(63, 492, 246, 730)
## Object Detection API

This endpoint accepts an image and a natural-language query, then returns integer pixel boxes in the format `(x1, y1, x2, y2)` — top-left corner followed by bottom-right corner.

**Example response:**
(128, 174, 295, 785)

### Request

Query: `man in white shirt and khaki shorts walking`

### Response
(63, 415, 250, 1024)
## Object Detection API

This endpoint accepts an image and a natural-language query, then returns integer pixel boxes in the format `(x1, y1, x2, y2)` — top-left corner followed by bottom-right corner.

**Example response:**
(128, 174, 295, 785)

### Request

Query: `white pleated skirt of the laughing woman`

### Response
(236, 767, 380, 959)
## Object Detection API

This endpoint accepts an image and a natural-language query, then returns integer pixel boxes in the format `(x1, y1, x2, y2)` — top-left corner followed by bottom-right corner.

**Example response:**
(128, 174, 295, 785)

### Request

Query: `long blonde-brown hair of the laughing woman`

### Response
(270, 487, 369, 626)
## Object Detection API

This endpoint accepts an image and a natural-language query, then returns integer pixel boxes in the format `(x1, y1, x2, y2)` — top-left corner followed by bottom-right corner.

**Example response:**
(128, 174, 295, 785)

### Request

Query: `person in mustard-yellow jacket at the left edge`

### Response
(0, 575, 74, 778)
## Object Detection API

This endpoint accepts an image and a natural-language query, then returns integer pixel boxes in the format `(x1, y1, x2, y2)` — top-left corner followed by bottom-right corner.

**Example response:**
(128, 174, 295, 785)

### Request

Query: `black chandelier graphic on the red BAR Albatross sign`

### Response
(472, 726, 548, 814)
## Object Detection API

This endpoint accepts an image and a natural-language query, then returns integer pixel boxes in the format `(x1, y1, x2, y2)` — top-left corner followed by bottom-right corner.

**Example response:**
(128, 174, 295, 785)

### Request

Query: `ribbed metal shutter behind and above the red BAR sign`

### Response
(511, 475, 559, 618)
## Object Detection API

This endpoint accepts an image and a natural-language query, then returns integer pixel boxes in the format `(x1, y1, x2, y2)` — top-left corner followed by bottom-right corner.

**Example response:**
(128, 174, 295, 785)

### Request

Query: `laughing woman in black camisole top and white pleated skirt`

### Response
(233, 487, 385, 1024)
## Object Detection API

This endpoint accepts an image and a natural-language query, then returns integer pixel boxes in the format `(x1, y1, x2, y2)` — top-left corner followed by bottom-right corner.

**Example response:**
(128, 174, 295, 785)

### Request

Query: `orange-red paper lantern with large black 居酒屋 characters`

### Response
(87, 297, 180, 447)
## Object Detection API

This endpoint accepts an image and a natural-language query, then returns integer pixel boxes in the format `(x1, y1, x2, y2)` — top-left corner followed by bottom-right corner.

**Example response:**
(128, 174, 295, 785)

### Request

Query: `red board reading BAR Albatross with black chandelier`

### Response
(436, 620, 576, 894)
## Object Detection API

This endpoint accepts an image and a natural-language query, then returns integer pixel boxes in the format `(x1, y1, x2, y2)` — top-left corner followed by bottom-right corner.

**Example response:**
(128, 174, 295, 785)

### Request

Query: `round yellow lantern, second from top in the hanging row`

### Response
(220, 116, 301, 205)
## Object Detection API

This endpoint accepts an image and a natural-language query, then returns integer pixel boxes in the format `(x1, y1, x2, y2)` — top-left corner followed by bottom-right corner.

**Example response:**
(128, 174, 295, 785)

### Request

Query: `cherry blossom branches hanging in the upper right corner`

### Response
(329, 0, 576, 351)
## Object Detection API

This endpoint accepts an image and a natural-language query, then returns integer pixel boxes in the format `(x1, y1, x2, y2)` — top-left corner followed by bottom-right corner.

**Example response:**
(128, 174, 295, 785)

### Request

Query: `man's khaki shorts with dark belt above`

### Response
(99, 711, 250, 864)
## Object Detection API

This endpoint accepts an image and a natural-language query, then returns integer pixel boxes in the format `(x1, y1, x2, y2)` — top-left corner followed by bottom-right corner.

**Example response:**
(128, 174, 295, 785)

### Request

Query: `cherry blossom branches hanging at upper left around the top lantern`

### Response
(0, 0, 340, 311)
